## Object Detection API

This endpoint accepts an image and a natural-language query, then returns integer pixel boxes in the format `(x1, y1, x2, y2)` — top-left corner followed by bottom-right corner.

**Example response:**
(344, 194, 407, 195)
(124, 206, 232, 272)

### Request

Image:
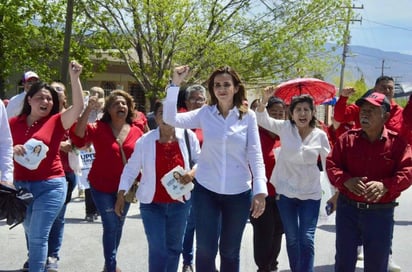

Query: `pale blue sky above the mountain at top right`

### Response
(350, 0, 412, 55)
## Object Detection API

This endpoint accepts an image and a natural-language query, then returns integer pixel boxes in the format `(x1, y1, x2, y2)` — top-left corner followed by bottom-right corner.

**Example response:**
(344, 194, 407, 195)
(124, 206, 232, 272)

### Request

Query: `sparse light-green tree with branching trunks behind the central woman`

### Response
(81, 0, 350, 107)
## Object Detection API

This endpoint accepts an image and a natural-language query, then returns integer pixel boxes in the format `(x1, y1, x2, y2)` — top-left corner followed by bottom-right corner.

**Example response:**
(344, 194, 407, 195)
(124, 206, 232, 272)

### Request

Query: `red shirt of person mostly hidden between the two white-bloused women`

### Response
(259, 127, 280, 196)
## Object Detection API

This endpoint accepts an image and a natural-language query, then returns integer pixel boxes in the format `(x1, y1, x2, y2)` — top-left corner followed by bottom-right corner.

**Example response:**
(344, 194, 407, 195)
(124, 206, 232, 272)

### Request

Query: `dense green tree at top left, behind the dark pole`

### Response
(0, 0, 108, 98)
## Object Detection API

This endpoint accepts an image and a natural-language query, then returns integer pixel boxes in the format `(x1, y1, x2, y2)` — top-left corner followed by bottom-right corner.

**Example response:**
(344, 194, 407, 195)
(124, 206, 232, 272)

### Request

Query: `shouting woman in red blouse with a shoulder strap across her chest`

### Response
(71, 90, 142, 272)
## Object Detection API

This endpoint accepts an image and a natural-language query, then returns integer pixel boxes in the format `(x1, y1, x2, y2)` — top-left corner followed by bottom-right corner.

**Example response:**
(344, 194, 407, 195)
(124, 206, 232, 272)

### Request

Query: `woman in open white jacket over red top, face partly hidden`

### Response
(115, 101, 200, 272)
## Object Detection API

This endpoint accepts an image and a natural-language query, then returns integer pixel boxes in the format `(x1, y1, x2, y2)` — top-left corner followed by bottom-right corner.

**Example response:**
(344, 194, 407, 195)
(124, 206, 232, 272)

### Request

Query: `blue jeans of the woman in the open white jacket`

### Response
(140, 202, 190, 272)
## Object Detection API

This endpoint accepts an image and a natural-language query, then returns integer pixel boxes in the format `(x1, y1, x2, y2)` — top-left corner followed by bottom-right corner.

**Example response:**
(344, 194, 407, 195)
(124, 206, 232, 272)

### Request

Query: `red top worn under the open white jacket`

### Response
(153, 141, 184, 203)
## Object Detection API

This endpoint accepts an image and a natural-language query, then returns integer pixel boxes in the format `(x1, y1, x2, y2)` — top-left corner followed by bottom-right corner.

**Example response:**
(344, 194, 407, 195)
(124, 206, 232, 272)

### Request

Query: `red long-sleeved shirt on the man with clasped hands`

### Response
(326, 128, 412, 203)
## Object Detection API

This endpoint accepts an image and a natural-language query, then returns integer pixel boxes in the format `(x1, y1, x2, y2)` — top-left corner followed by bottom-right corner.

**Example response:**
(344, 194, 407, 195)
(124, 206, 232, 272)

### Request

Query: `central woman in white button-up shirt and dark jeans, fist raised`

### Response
(164, 66, 267, 272)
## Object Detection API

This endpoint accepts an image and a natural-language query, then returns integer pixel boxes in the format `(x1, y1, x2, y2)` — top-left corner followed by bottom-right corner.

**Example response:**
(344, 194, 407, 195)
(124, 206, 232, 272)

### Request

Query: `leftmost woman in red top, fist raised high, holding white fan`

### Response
(10, 61, 83, 271)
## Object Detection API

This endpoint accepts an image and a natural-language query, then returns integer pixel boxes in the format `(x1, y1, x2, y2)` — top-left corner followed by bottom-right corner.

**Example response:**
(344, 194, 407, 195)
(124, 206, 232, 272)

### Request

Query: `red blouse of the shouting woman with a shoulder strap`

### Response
(70, 121, 143, 193)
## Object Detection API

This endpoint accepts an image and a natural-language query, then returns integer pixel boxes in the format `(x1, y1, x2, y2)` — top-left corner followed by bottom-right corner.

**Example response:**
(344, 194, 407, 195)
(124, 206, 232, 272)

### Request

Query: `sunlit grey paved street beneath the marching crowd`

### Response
(0, 189, 412, 272)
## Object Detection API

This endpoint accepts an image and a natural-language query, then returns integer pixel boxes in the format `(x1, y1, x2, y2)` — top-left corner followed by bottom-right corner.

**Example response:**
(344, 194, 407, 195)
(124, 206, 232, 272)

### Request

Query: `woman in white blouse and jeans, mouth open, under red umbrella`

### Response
(256, 87, 330, 272)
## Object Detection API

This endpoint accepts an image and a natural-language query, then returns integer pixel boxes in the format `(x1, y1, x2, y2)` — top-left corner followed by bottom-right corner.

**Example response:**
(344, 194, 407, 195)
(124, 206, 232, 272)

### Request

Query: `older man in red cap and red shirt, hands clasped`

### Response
(326, 92, 412, 272)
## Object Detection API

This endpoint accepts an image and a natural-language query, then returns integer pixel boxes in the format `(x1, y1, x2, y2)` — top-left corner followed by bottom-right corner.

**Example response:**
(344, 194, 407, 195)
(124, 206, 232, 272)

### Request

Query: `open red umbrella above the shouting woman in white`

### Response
(275, 78, 336, 105)
